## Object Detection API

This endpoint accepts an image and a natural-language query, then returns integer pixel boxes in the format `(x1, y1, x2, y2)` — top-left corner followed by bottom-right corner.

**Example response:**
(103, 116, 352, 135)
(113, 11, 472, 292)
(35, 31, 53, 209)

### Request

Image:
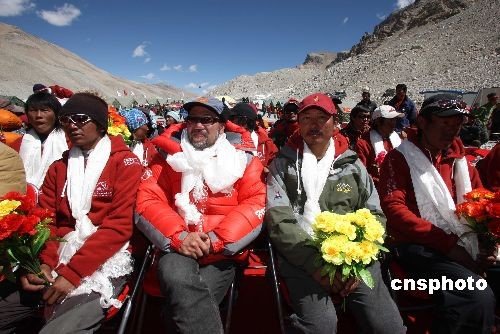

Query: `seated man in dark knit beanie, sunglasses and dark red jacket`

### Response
(0, 93, 142, 333)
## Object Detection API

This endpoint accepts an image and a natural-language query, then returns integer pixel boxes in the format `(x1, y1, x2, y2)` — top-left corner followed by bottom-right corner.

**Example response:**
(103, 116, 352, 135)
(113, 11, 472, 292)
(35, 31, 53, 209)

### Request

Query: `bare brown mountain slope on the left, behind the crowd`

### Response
(0, 23, 194, 102)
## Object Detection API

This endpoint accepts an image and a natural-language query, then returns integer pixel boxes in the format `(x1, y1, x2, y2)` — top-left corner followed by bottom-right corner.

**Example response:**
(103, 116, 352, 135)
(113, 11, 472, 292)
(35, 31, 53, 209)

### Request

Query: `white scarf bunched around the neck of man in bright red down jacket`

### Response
(167, 129, 247, 230)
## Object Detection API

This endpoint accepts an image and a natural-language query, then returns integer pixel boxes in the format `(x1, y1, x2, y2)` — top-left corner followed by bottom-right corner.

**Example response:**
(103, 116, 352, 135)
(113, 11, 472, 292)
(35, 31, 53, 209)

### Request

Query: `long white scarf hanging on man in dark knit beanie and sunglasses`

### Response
(59, 136, 133, 308)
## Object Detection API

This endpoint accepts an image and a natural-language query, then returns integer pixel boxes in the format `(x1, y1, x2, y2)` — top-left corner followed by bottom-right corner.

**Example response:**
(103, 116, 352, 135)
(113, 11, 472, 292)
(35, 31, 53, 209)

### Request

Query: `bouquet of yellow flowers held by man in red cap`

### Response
(311, 209, 388, 288)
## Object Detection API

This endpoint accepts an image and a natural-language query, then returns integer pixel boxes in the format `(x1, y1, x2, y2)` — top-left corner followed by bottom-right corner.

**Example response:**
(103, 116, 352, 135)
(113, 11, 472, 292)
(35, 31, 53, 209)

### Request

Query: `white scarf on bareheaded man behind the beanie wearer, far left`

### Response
(19, 129, 68, 189)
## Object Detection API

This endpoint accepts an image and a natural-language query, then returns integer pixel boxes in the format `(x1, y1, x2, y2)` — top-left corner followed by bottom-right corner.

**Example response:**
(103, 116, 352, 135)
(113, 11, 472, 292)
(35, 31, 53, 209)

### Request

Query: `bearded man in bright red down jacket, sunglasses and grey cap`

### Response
(133, 97, 265, 333)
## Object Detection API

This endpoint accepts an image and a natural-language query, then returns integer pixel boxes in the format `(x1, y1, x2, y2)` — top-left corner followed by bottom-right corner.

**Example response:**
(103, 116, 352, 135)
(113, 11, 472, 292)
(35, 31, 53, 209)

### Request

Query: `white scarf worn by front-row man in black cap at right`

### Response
(397, 140, 479, 260)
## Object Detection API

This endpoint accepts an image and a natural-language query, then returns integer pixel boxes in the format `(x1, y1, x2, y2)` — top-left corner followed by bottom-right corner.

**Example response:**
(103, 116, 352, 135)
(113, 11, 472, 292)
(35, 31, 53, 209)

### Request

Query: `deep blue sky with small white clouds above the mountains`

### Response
(0, 0, 414, 93)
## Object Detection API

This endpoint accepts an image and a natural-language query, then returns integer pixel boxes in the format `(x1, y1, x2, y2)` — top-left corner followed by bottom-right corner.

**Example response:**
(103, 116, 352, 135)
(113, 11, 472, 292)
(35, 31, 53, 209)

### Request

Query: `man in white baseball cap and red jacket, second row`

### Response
(355, 105, 404, 188)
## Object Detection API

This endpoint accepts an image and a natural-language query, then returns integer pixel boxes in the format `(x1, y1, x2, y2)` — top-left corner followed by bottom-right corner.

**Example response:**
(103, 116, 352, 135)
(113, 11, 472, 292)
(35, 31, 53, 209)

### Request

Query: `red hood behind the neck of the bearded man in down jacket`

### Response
(152, 121, 255, 154)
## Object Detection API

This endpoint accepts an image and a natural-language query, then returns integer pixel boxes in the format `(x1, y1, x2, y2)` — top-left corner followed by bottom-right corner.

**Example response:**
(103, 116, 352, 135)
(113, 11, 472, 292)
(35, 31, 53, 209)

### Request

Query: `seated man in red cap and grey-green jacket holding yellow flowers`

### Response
(265, 93, 405, 333)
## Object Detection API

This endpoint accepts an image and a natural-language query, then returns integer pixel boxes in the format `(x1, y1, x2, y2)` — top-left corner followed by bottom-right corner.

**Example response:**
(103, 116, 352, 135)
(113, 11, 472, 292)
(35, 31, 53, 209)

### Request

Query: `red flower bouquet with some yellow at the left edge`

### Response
(0, 192, 53, 279)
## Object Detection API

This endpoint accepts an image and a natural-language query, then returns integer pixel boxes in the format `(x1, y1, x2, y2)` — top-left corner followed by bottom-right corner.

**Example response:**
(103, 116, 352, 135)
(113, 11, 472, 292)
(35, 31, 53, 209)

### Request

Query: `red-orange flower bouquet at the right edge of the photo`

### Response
(456, 188, 500, 247)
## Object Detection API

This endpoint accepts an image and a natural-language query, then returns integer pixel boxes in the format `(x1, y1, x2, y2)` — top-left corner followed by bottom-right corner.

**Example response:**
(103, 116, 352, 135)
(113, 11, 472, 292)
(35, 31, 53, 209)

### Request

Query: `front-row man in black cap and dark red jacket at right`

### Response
(379, 94, 496, 333)
